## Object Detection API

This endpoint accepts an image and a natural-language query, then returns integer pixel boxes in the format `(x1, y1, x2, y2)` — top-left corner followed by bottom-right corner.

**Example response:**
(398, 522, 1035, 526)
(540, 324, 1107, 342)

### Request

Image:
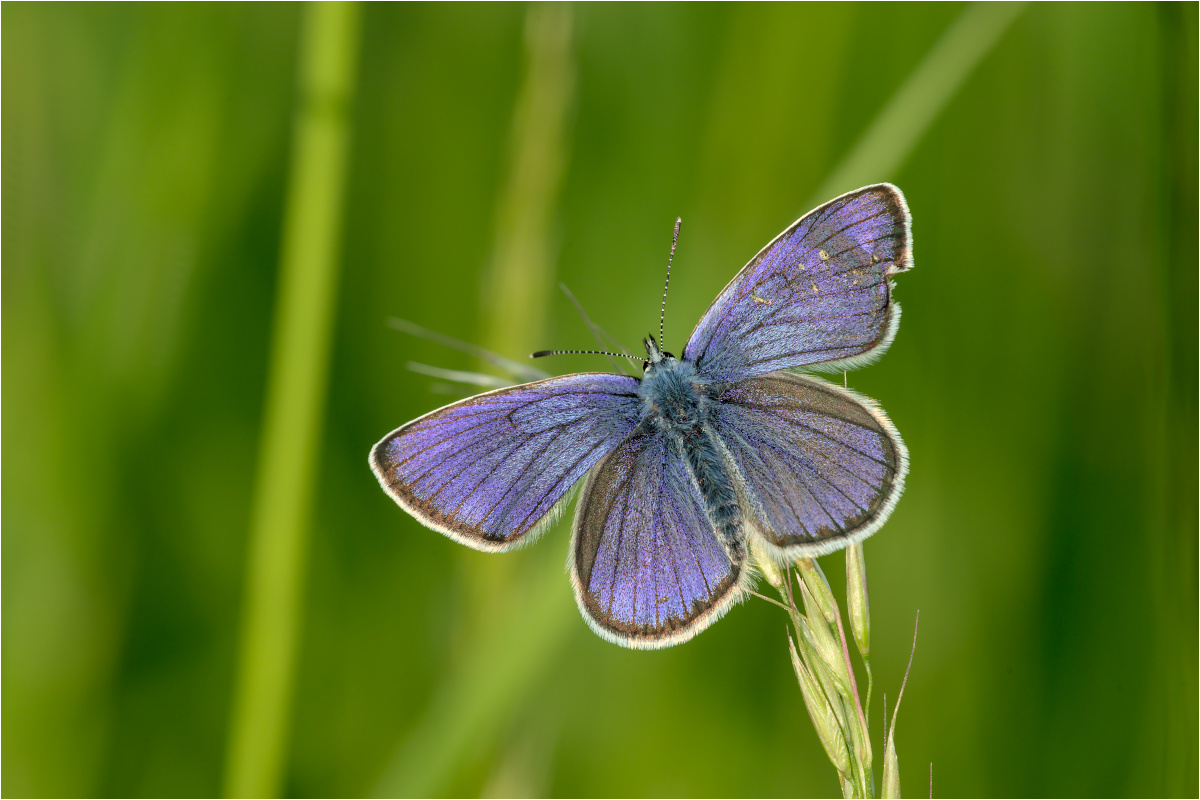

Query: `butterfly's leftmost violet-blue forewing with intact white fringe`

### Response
(370, 373, 640, 551)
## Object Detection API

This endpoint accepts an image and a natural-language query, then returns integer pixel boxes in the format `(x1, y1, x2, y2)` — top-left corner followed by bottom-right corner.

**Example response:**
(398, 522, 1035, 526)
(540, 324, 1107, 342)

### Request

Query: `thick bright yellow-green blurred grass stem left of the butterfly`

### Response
(224, 2, 359, 796)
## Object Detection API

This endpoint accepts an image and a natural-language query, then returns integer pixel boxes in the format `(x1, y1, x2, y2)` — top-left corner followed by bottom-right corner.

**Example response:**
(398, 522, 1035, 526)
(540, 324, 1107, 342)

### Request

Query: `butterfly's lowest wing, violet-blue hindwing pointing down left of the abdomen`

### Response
(571, 428, 742, 648)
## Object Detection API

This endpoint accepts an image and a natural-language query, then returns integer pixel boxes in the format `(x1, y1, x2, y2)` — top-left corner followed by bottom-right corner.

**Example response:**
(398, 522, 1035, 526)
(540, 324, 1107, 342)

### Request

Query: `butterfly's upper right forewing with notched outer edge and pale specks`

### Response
(684, 184, 912, 383)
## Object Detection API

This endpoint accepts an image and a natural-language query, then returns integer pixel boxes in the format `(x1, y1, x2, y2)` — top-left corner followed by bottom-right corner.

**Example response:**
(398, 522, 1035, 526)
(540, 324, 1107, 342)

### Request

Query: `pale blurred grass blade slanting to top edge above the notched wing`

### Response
(804, 2, 1025, 210)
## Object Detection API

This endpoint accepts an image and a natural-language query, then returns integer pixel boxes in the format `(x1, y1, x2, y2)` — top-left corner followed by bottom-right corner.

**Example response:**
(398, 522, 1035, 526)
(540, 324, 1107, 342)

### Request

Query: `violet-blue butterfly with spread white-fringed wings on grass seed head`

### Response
(370, 184, 912, 649)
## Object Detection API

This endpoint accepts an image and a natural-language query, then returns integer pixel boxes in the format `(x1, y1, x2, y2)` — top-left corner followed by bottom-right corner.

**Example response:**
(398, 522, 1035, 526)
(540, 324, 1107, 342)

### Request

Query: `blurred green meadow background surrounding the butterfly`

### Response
(2, 4, 1198, 796)
